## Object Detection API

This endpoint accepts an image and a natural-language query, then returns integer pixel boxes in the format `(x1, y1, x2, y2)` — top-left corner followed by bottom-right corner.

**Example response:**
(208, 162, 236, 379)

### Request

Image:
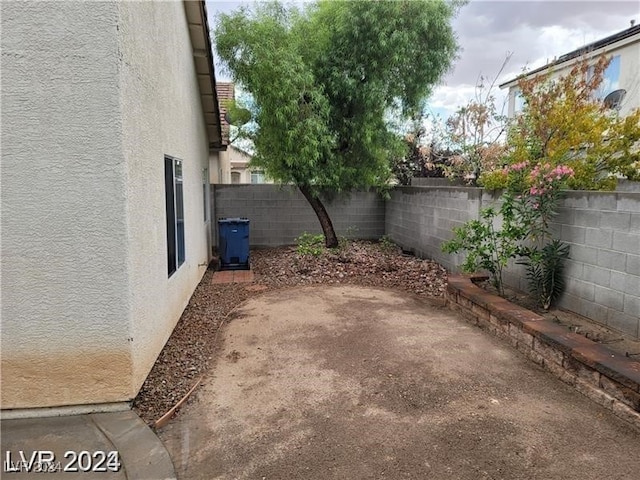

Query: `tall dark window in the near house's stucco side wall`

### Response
(164, 156, 185, 276)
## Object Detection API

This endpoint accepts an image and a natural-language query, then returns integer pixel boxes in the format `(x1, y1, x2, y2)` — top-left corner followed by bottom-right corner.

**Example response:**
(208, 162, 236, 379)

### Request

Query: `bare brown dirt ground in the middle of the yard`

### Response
(158, 285, 640, 480)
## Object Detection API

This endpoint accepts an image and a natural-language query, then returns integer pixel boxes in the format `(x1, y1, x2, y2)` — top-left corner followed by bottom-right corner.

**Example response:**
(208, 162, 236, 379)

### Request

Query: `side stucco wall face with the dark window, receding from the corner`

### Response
(119, 2, 210, 398)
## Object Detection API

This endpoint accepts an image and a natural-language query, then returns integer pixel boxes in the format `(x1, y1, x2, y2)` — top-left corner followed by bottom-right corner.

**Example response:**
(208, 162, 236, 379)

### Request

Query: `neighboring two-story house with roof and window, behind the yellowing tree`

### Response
(500, 25, 640, 117)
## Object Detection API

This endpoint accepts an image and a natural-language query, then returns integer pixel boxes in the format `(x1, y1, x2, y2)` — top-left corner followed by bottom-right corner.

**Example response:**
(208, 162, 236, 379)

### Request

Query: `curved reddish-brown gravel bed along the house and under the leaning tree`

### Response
(133, 241, 447, 424)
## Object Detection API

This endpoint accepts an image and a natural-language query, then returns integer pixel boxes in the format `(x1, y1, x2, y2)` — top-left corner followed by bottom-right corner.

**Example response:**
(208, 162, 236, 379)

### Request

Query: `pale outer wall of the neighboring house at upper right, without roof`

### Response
(508, 35, 640, 117)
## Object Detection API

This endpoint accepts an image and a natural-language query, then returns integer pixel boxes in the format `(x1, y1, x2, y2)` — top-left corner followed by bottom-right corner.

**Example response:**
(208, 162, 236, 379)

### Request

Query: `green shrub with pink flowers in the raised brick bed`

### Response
(442, 161, 574, 309)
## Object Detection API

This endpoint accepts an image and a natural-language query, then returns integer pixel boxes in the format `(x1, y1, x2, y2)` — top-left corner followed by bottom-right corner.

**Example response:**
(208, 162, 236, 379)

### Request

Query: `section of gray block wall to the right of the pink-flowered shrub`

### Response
(554, 192, 640, 337)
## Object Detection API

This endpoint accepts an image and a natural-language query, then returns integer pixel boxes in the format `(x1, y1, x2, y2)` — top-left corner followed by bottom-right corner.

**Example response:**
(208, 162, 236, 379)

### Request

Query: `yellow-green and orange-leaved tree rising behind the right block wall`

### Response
(493, 55, 640, 190)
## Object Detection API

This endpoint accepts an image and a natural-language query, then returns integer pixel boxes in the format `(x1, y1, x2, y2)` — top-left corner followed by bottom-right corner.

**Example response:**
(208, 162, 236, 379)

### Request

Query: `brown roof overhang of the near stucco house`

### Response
(183, 0, 227, 152)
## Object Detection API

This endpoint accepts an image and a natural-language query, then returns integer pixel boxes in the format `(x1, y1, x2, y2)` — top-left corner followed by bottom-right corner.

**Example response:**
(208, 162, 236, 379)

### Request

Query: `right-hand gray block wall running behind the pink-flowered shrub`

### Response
(385, 187, 640, 338)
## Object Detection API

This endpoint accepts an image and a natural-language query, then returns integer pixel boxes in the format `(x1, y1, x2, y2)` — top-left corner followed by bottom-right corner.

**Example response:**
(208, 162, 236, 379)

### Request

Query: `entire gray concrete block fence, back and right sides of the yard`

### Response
(212, 184, 640, 338)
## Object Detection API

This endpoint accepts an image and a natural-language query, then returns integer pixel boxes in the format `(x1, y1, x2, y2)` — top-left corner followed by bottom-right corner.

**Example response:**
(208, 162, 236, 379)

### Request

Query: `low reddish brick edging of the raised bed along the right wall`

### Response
(446, 275, 640, 430)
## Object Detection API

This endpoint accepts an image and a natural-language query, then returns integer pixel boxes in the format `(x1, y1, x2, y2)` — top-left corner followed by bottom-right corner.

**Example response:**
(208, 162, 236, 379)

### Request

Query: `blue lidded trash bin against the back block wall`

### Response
(218, 218, 249, 270)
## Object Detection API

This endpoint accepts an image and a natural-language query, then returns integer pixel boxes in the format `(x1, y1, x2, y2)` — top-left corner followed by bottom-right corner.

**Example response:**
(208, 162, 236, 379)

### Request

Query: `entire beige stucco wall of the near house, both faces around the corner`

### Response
(1, 1, 210, 409)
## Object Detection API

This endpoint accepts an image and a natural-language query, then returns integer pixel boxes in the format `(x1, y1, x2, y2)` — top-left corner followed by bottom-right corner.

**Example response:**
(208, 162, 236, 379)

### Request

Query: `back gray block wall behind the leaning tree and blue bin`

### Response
(211, 184, 385, 247)
